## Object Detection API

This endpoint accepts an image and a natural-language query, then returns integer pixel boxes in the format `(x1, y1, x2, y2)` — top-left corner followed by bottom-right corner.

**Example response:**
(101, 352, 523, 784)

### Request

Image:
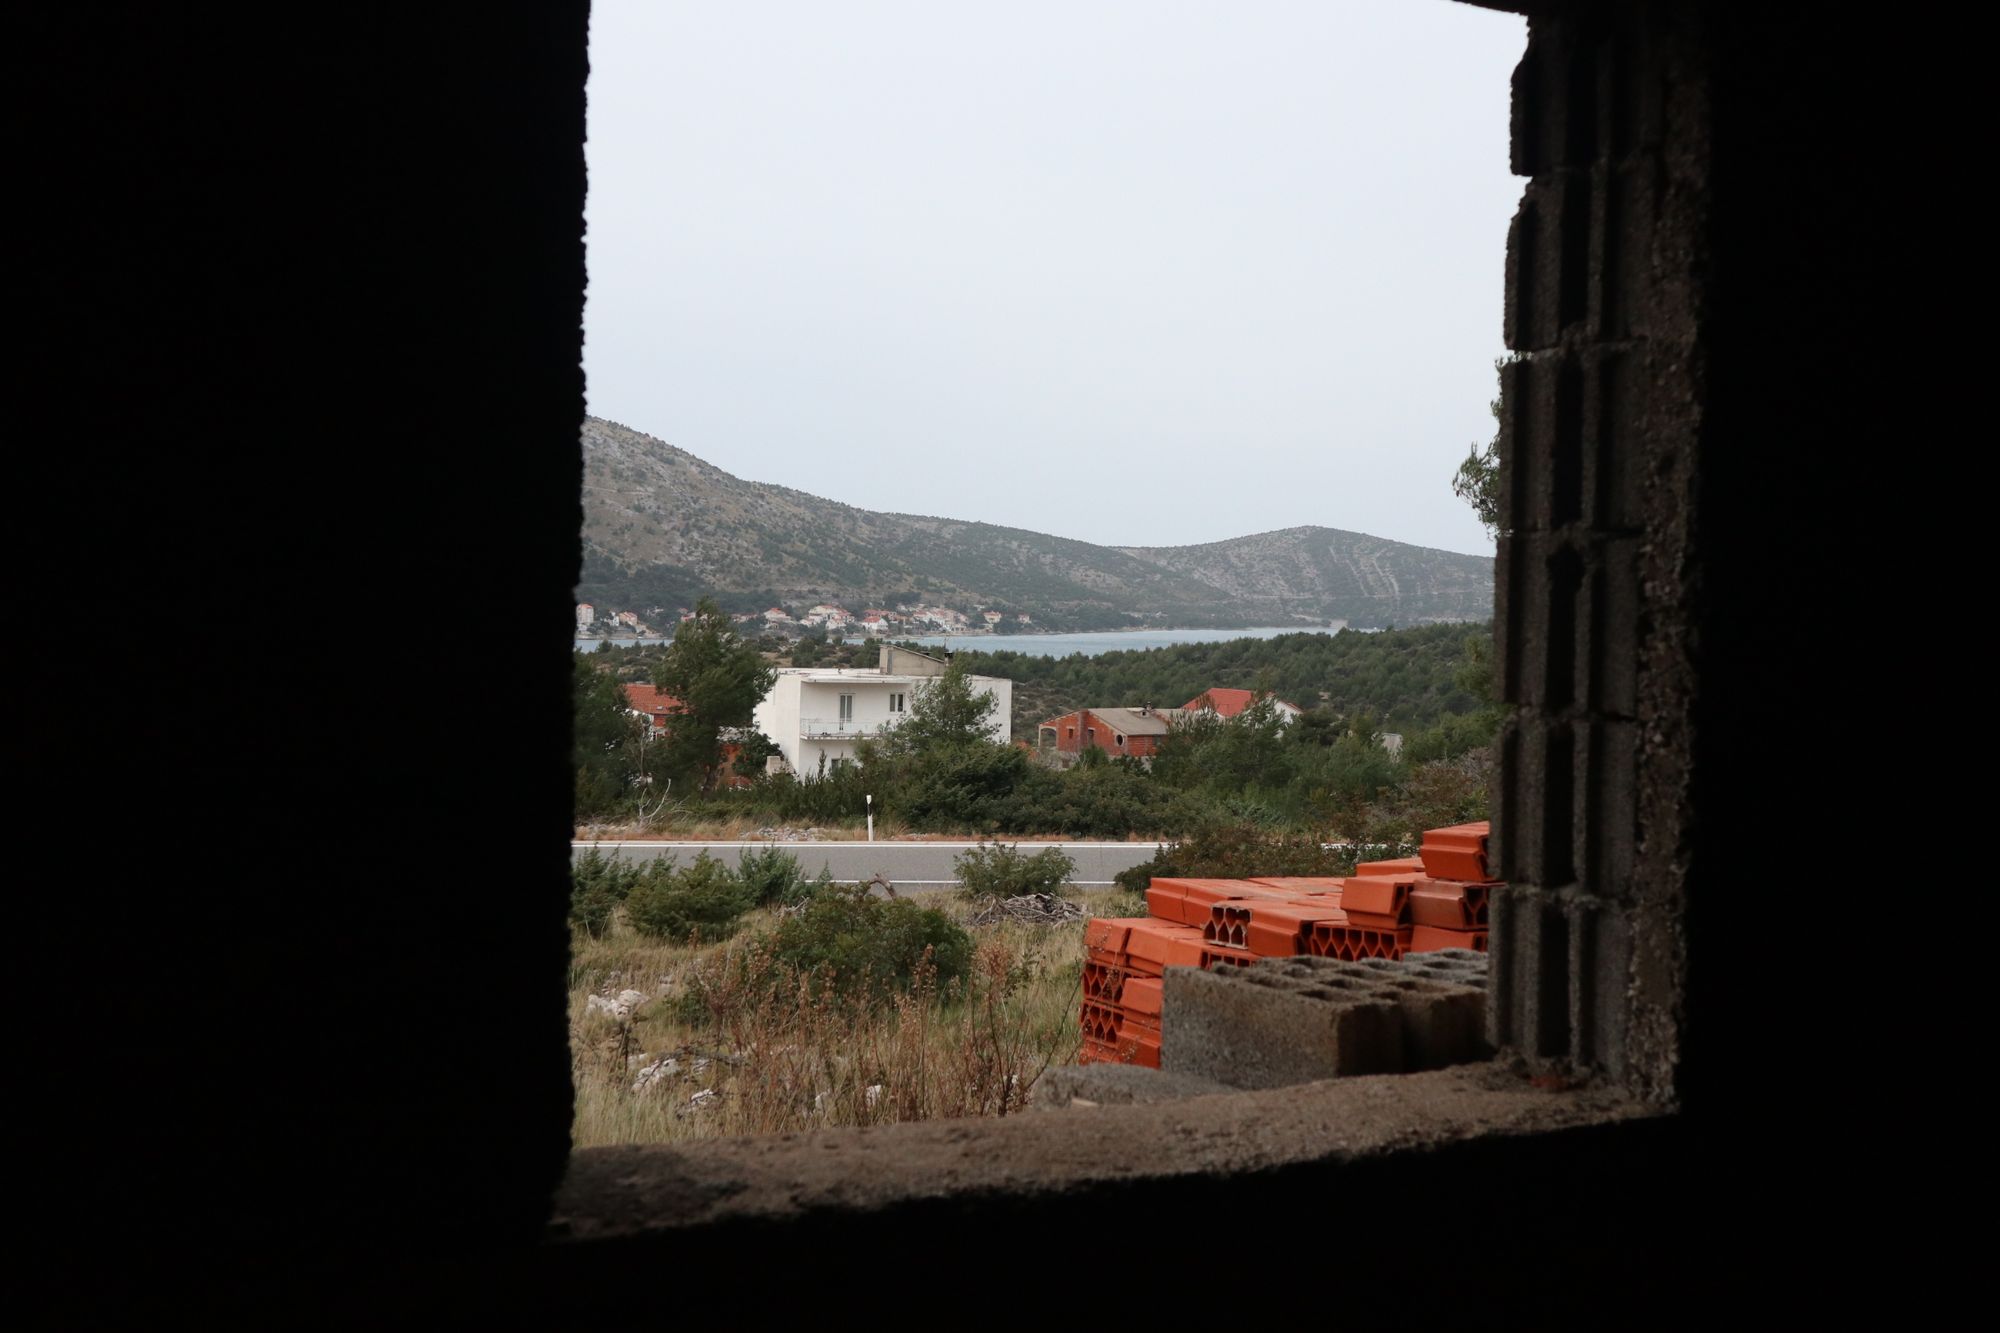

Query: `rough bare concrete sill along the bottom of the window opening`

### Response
(550, 1065, 1672, 1247)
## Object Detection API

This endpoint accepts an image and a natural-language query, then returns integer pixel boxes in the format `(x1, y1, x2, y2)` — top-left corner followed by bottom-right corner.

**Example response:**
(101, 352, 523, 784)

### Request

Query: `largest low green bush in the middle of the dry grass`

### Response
(764, 889, 972, 1001)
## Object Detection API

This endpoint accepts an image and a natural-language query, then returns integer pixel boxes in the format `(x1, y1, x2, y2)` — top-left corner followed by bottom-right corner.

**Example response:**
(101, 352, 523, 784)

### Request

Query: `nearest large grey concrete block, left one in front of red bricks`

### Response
(1160, 959, 1404, 1089)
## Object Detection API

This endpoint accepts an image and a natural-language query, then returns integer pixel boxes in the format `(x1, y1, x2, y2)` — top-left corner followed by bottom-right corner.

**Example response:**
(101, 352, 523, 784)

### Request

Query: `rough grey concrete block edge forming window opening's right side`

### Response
(1490, 12, 1708, 1099)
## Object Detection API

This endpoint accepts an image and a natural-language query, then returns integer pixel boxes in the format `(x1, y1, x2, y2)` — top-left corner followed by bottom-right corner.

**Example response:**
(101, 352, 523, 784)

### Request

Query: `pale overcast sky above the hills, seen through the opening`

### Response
(584, 0, 1526, 552)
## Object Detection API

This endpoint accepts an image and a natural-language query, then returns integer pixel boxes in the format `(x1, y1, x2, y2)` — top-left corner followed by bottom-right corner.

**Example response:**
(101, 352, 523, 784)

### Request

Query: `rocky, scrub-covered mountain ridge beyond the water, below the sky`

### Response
(578, 418, 1494, 628)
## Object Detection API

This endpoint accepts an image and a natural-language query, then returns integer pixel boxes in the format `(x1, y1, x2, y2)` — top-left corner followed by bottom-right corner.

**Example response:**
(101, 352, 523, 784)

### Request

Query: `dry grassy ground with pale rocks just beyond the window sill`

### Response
(570, 891, 1144, 1147)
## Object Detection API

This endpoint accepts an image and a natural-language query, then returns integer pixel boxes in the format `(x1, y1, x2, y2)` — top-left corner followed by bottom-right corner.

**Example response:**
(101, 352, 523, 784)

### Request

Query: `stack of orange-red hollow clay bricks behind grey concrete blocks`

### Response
(1078, 823, 1498, 1069)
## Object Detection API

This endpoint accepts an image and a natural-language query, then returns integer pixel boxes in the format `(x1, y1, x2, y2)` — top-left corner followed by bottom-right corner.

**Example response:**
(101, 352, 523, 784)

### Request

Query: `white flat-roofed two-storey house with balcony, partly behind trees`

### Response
(750, 646, 1014, 779)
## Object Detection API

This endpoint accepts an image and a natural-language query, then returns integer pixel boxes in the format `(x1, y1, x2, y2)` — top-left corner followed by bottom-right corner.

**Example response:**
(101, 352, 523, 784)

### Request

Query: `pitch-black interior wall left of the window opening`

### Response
(19, 0, 588, 1295)
